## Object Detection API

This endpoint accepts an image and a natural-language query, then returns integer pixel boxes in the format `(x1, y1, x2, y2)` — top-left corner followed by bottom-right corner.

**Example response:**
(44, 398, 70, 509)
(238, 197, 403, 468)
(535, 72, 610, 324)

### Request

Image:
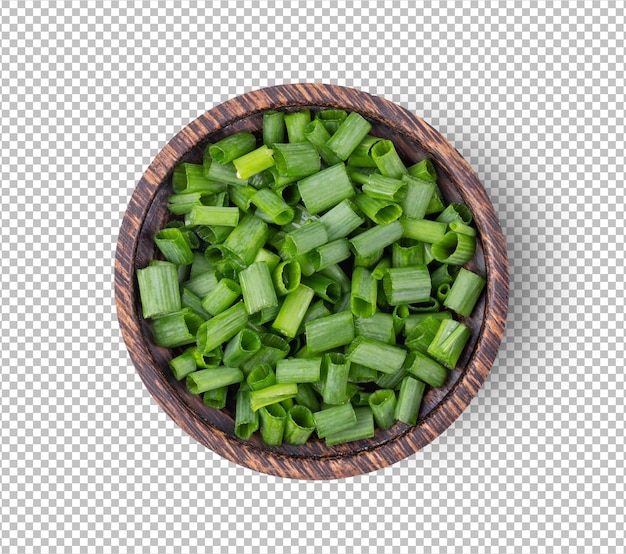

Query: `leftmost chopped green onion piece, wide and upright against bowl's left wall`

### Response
(137, 261, 181, 319)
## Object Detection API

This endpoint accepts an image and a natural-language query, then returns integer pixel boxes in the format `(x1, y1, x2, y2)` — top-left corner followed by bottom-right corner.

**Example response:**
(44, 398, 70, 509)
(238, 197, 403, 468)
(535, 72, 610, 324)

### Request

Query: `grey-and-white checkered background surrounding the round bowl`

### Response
(0, 4, 626, 554)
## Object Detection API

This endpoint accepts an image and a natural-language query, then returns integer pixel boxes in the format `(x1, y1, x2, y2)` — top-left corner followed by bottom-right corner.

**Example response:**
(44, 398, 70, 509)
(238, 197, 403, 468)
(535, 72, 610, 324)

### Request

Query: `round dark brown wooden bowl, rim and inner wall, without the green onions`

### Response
(115, 84, 509, 479)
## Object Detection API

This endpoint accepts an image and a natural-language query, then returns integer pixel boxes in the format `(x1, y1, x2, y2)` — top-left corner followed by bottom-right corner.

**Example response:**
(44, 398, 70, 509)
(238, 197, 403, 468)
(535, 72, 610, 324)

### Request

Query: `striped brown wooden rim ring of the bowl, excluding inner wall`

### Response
(115, 83, 509, 479)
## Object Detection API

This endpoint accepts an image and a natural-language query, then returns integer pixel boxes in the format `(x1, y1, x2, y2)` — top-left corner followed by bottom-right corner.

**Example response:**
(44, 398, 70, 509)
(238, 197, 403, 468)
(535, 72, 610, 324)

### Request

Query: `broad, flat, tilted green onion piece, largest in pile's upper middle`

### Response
(298, 163, 354, 214)
